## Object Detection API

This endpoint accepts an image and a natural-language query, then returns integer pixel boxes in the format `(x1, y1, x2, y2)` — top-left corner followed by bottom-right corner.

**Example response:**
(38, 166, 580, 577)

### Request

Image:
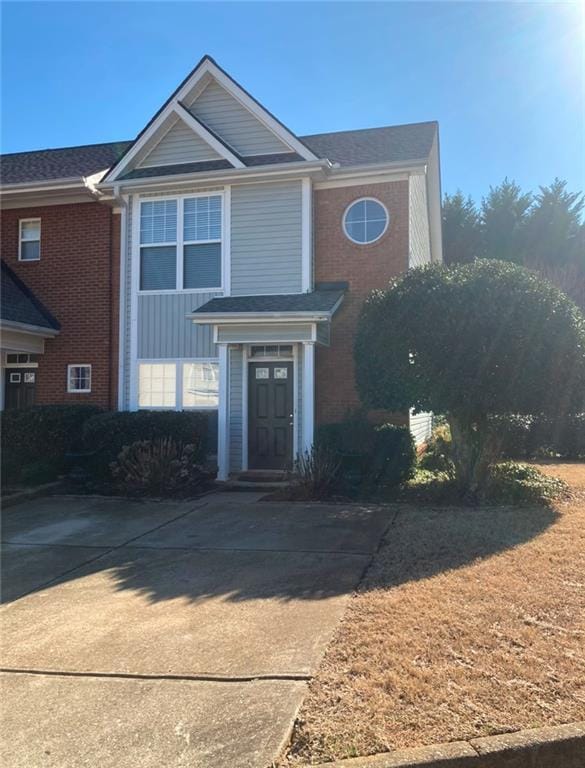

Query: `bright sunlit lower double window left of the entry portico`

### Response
(138, 360, 219, 410)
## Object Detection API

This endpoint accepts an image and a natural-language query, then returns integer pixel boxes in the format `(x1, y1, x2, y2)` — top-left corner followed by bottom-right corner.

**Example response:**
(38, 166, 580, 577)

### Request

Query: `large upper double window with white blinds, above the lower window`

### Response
(140, 195, 222, 291)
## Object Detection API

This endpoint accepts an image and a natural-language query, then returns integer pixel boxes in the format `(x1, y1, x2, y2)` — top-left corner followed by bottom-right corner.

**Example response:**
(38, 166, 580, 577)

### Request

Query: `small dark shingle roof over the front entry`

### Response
(193, 291, 344, 315)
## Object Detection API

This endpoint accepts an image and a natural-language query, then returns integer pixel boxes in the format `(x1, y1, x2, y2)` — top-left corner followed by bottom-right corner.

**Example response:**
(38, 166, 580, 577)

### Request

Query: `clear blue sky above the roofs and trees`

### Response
(1, 2, 585, 198)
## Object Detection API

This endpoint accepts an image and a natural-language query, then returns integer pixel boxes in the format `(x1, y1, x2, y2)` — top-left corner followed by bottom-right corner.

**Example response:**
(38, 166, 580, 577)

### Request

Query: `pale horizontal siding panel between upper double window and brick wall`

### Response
(231, 181, 302, 296)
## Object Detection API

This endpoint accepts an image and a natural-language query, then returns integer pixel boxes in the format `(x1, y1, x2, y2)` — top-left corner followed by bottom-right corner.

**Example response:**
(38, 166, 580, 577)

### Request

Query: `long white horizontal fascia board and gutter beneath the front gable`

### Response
(98, 160, 329, 193)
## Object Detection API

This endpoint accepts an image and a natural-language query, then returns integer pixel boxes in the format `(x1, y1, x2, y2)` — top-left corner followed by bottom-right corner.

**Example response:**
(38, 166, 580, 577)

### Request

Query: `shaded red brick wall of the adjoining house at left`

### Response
(0, 202, 120, 407)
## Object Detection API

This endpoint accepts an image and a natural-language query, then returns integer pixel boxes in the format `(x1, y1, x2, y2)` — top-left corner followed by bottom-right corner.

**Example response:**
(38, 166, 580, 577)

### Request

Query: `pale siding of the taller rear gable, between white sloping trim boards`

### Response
(189, 81, 291, 156)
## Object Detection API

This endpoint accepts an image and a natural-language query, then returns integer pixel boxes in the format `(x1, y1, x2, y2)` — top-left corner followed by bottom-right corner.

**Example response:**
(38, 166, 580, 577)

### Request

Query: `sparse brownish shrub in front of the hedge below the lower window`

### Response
(111, 437, 206, 496)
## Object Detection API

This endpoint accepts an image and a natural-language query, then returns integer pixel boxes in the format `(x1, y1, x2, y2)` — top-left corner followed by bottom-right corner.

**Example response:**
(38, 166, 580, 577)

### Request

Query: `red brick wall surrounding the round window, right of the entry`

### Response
(314, 181, 408, 423)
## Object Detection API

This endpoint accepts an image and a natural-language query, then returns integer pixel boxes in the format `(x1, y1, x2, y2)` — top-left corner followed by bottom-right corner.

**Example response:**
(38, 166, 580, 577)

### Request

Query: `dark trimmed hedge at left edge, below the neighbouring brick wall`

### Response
(2, 404, 102, 482)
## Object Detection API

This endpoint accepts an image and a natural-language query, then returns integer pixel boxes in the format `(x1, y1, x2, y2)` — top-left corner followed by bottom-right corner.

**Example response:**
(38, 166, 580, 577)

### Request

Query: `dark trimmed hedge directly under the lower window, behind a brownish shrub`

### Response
(83, 411, 208, 479)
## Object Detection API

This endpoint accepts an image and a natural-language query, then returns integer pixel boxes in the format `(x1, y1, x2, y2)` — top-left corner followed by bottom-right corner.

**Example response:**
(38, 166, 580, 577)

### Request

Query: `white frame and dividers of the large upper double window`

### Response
(138, 188, 225, 296)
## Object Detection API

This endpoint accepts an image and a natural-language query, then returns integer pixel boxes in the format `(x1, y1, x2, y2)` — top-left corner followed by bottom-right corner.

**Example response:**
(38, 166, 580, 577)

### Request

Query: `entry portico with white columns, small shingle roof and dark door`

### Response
(189, 289, 343, 480)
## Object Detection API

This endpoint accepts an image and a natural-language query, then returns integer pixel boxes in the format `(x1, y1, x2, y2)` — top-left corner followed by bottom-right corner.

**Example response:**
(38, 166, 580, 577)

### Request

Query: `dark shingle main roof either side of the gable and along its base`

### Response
(0, 122, 437, 184)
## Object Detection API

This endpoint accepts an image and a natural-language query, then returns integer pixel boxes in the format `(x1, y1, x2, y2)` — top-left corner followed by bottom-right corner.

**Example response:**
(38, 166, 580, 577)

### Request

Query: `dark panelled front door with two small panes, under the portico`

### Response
(248, 362, 293, 469)
